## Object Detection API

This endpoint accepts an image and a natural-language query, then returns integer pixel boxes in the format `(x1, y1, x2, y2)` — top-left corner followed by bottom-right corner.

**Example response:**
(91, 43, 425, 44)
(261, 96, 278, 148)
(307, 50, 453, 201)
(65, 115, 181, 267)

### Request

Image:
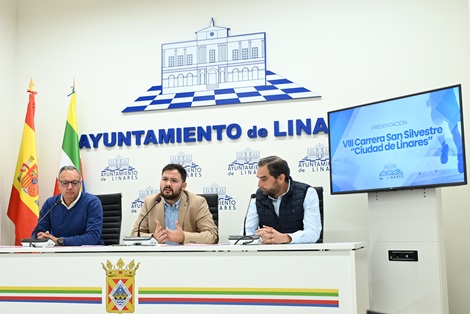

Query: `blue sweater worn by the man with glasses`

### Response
(32, 192, 104, 246)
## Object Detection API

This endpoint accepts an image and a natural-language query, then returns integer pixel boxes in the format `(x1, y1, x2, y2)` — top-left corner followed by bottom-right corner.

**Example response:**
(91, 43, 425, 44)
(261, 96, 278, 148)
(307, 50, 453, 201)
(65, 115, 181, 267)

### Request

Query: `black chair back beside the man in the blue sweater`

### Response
(96, 193, 122, 245)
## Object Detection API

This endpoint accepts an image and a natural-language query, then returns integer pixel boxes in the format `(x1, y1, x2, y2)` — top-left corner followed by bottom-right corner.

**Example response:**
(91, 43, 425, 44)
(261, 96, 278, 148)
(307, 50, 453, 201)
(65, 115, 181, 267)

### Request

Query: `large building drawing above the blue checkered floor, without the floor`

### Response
(161, 18, 266, 94)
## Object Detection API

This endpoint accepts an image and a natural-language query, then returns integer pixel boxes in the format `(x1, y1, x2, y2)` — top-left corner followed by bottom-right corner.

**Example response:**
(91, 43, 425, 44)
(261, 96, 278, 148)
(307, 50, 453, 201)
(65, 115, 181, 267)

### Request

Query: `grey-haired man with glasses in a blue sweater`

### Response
(32, 166, 104, 246)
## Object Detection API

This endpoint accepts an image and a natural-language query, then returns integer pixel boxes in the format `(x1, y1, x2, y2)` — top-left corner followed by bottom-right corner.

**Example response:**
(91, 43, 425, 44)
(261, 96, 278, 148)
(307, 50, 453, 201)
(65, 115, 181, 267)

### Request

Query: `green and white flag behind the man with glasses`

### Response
(54, 82, 85, 195)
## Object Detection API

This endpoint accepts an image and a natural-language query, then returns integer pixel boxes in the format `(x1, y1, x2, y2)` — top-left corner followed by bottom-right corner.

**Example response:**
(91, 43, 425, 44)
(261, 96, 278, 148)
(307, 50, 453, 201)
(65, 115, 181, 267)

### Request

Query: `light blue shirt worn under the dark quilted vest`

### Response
(242, 182, 322, 244)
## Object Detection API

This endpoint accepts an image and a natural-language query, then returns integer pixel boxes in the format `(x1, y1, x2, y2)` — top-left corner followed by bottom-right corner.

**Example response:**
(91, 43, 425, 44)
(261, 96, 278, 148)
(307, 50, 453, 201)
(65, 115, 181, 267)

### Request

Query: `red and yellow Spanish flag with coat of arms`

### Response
(7, 80, 39, 245)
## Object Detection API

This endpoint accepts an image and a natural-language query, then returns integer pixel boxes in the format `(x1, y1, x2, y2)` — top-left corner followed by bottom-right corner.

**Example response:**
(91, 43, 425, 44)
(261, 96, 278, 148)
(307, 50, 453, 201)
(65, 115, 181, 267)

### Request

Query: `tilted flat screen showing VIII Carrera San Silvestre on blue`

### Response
(328, 85, 467, 194)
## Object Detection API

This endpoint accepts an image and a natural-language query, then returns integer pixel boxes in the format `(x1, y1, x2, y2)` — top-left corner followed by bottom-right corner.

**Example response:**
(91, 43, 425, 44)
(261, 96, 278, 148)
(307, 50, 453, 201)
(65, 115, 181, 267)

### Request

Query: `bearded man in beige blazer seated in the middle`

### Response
(132, 164, 219, 244)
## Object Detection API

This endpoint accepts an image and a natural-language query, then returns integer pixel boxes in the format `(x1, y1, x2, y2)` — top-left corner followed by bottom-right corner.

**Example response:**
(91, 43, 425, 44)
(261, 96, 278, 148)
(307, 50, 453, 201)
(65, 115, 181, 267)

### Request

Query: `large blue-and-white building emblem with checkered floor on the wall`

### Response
(122, 19, 320, 113)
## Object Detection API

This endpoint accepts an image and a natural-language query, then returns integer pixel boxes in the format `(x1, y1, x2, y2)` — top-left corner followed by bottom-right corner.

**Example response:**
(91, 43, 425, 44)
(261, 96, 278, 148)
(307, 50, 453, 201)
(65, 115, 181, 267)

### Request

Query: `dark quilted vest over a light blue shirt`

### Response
(256, 178, 310, 233)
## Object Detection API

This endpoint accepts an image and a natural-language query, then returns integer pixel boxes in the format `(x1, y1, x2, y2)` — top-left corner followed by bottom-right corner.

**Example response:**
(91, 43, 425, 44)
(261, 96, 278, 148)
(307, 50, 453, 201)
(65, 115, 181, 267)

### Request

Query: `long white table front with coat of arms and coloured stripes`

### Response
(0, 243, 369, 314)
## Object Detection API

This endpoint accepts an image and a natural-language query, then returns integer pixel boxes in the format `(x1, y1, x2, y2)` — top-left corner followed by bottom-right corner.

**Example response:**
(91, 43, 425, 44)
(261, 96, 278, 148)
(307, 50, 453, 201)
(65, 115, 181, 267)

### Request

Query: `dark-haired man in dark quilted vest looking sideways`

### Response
(246, 156, 322, 244)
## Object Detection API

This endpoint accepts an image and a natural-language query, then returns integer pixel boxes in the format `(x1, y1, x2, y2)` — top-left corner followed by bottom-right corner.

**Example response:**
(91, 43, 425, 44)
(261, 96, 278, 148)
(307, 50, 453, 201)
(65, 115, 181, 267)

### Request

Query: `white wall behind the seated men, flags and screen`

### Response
(0, 0, 470, 313)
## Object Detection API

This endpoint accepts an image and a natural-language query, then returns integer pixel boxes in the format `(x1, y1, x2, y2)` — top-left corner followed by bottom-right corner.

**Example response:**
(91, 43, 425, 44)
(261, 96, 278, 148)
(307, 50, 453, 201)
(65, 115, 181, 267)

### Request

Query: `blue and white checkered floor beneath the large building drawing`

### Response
(122, 71, 320, 113)
